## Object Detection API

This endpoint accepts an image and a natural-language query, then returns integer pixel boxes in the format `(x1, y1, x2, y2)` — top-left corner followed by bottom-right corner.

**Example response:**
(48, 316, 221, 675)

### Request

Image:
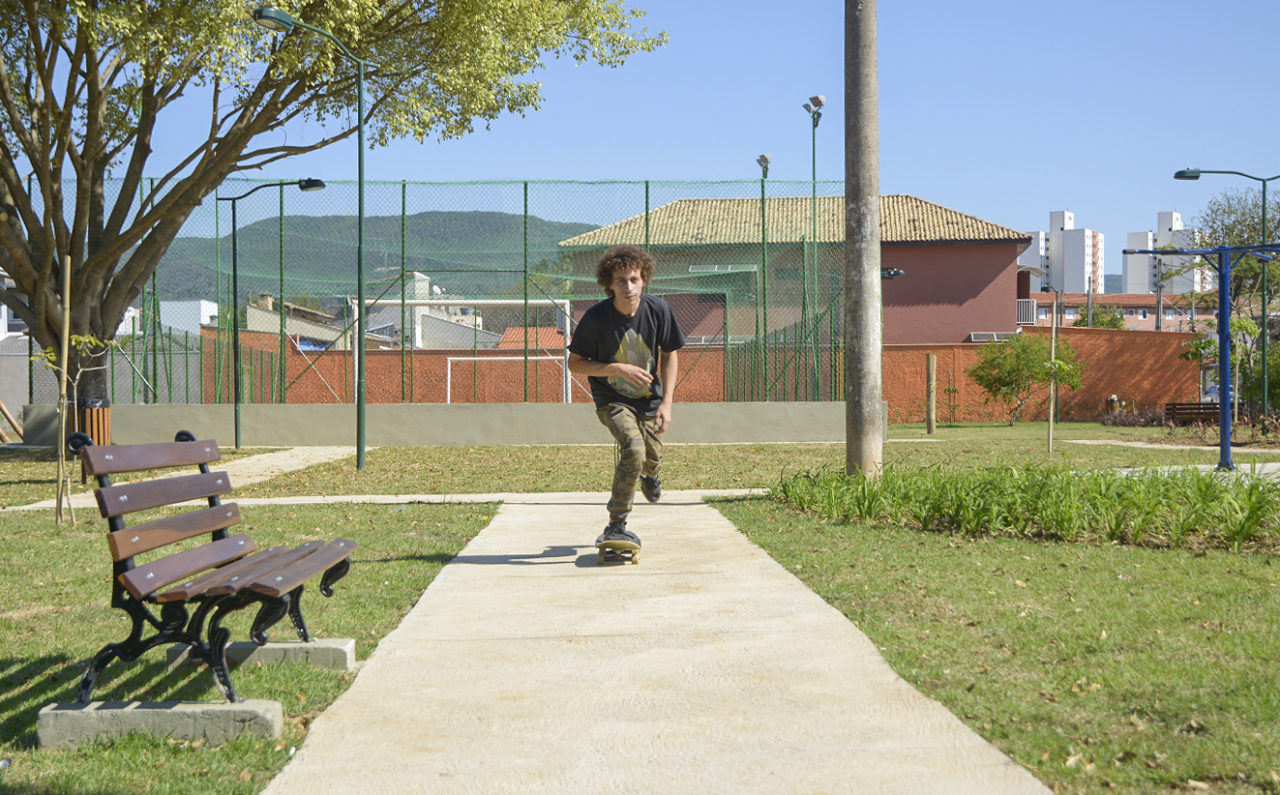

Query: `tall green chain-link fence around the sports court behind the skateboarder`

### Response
(20, 179, 844, 405)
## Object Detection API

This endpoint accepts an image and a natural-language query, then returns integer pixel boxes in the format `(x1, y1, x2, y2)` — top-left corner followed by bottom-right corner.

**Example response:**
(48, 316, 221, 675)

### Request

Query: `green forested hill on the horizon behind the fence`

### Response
(156, 211, 595, 301)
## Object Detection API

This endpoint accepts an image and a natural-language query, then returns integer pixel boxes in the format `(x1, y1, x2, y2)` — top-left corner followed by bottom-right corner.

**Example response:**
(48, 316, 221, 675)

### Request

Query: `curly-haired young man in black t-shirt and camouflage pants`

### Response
(568, 246, 685, 548)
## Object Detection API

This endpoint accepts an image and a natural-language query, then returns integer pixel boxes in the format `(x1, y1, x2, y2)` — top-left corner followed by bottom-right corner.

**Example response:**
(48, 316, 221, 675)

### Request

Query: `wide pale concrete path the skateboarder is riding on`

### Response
(266, 492, 1047, 795)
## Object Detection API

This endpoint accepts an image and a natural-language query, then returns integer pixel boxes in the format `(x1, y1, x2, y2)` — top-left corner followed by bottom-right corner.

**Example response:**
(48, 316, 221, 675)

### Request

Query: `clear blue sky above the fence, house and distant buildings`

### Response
(157, 0, 1280, 273)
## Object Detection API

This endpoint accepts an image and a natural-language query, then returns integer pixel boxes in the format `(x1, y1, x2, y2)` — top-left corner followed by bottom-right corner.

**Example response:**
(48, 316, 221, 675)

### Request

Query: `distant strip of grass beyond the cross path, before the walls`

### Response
(230, 422, 1280, 497)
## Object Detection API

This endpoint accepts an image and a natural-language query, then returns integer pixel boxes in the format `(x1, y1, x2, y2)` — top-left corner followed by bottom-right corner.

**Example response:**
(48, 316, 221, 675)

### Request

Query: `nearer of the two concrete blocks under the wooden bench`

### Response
(36, 699, 284, 748)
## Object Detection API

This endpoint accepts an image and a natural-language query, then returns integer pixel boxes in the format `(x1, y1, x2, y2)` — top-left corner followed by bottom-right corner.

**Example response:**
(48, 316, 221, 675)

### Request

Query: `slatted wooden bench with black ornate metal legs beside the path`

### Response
(68, 431, 356, 704)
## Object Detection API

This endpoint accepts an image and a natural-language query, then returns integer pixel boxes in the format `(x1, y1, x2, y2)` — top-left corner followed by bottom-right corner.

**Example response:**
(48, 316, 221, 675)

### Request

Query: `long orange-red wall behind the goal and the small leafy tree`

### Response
(205, 328, 1198, 422)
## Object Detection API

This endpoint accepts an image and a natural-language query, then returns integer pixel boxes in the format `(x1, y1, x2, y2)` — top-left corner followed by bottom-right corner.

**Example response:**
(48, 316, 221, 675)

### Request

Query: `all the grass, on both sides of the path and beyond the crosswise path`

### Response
(0, 424, 1280, 794)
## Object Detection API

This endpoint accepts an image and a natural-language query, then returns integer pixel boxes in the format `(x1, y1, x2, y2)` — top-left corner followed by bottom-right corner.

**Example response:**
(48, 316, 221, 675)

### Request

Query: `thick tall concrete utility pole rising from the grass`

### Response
(844, 0, 884, 478)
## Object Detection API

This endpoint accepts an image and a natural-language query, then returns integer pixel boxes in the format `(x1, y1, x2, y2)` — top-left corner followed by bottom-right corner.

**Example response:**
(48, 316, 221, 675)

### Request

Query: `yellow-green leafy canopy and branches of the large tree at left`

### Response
(0, 0, 666, 394)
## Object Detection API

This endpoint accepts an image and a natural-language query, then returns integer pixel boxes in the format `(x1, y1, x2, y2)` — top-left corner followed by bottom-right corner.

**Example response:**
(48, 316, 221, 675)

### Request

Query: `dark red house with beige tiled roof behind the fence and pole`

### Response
(559, 195, 1034, 343)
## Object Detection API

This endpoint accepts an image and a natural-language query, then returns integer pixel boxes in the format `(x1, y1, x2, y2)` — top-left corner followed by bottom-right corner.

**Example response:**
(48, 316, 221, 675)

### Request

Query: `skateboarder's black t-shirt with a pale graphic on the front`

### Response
(568, 293, 685, 416)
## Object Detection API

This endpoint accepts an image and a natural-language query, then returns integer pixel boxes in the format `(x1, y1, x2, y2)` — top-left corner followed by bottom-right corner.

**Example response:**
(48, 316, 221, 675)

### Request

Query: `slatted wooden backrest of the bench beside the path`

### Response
(79, 434, 256, 600)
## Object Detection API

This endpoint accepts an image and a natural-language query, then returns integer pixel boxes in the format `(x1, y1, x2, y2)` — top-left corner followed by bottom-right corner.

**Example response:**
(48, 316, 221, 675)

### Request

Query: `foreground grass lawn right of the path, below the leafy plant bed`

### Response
(716, 498, 1280, 792)
